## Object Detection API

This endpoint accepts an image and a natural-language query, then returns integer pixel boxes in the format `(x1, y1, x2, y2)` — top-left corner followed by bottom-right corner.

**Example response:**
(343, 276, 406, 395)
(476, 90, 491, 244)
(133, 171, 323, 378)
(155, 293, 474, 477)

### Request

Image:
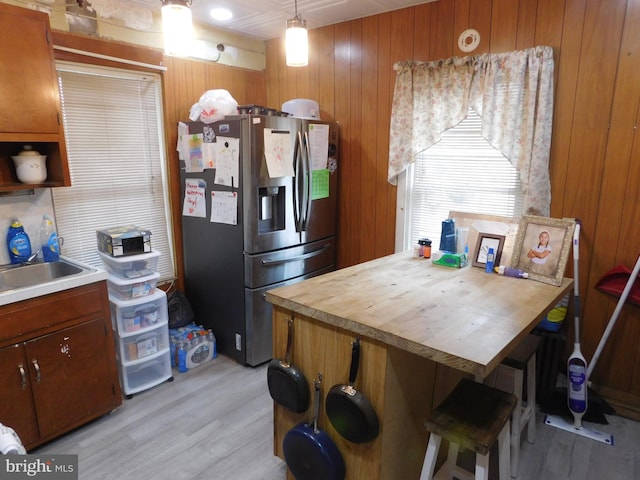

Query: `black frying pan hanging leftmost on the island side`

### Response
(267, 319, 309, 413)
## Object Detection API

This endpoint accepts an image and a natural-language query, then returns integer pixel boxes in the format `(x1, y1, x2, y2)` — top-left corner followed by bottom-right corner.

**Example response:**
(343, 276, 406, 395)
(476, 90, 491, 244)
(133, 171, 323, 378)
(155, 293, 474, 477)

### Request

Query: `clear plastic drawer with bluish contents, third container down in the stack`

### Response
(109, 289, 169, 337)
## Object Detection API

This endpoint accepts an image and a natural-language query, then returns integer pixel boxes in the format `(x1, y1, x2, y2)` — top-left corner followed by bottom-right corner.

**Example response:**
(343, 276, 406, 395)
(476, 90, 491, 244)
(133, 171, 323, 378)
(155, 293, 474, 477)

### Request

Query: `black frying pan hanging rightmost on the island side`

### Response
(326, 337, 380, 443)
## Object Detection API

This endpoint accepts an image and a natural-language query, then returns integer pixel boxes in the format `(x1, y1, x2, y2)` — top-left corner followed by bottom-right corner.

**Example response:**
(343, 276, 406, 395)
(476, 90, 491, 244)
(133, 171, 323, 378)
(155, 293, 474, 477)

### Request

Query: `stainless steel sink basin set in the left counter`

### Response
(0, 260, 87, 292)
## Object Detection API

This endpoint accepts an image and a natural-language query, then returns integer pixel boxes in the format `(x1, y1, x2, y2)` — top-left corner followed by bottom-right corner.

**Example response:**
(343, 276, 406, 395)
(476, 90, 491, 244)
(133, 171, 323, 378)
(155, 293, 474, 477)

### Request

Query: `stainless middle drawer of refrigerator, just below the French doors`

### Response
(244, 237, 336, 288)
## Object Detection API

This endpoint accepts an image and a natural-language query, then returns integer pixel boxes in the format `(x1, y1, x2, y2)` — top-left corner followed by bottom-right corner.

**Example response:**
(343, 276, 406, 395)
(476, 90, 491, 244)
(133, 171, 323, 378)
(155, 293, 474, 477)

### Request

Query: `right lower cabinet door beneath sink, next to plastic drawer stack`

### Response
(25, 318, 119, 437)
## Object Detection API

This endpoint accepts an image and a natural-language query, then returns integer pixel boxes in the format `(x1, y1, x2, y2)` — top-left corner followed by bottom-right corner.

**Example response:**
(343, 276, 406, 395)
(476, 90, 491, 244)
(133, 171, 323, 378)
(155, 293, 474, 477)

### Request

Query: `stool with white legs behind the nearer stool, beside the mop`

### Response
(501, 334, 540, 477)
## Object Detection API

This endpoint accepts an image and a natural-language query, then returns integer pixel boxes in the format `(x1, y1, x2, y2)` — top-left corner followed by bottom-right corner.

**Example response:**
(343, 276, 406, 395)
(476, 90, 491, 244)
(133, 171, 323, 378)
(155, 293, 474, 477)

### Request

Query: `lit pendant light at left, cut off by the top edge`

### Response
(162, 0, 193, 57)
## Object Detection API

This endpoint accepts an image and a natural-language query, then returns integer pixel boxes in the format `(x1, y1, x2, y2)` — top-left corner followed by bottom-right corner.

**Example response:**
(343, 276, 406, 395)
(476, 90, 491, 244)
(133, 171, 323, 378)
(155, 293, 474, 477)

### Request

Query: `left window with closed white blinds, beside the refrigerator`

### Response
(52, 62, 175, 280)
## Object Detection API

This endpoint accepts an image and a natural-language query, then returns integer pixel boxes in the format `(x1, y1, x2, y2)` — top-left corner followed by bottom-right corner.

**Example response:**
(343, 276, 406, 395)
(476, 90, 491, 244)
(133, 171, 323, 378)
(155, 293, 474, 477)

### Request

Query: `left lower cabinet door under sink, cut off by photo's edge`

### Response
(0, 344, 39, 445)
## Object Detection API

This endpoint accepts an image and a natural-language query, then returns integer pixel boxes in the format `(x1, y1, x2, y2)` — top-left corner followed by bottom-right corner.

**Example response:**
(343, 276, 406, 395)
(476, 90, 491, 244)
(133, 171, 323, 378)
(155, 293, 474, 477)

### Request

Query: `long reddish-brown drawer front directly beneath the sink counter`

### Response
(0, 281, 108, 346)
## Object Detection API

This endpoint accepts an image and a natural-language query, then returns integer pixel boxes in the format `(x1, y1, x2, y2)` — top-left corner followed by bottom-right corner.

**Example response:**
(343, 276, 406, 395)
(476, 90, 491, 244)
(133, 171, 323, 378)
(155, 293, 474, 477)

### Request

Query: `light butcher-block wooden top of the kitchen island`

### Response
(266, 252, 573, 377)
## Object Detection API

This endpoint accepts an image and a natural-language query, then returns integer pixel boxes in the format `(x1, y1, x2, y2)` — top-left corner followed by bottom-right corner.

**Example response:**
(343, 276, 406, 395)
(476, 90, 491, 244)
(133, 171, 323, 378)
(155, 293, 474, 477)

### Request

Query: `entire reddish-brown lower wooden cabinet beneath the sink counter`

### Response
(0, 282, 122, 450)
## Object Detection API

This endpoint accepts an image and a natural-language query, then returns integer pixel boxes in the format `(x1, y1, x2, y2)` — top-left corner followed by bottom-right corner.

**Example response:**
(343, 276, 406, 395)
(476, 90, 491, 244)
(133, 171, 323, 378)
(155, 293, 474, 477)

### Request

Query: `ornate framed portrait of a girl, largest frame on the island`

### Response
(511, 215, 576, 285)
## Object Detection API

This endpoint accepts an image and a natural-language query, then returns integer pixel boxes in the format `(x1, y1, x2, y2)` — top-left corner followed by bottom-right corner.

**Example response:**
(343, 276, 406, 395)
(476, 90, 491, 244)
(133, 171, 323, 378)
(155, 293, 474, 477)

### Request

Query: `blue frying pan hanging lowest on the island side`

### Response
(282, 374, 346, 480)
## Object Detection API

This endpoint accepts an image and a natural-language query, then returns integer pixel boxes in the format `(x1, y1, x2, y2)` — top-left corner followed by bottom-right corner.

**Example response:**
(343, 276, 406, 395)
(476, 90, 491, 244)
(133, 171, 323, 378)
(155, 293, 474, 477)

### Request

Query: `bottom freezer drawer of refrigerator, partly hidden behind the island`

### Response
(244, 265, 334, 366)
